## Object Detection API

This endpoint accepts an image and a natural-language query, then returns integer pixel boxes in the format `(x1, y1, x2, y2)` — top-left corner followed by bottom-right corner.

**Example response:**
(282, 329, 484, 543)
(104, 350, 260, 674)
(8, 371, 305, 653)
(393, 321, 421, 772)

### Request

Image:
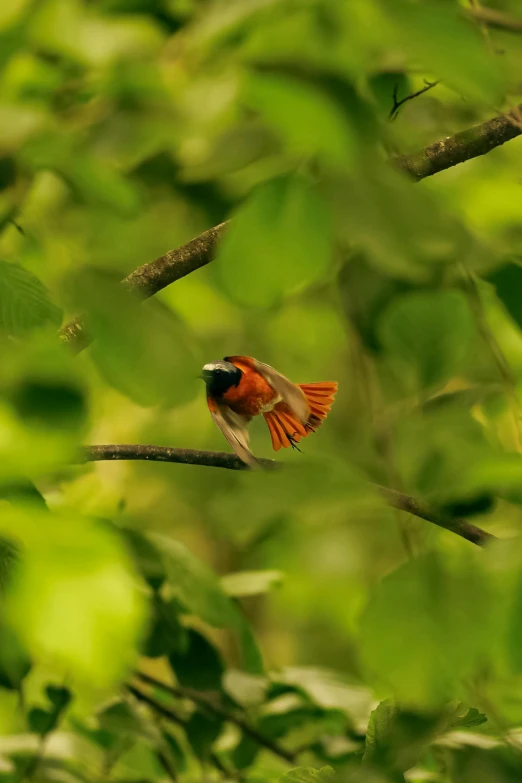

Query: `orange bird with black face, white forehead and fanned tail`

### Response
(201, 356, 337, 468)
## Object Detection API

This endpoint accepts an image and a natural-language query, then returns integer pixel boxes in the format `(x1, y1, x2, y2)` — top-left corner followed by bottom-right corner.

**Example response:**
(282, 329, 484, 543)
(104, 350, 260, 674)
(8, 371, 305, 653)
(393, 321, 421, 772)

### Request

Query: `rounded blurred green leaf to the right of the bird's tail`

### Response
(379, 291, 475, 389)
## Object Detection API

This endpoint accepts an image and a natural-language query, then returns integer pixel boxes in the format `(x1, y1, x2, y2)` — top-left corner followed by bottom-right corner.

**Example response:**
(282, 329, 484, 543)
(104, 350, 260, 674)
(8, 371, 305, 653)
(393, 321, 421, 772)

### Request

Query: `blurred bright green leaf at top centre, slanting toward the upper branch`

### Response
(245, 73, 355, 166)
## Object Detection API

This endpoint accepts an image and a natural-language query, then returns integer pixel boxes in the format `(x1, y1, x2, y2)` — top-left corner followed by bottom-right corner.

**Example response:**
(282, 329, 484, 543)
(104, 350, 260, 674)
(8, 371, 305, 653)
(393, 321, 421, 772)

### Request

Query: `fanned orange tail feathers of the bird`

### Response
(263, 381, 337, 451)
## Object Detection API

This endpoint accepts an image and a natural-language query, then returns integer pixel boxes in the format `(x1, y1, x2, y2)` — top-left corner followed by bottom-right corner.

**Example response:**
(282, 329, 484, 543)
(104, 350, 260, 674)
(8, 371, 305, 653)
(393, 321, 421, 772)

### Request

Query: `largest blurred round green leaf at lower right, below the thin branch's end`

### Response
(361, 551, 501, 710)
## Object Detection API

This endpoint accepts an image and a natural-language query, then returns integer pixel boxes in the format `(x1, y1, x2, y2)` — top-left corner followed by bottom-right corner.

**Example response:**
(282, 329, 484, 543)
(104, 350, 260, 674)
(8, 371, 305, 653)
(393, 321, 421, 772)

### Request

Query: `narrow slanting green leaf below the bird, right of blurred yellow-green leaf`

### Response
(150, 534, 237, 628)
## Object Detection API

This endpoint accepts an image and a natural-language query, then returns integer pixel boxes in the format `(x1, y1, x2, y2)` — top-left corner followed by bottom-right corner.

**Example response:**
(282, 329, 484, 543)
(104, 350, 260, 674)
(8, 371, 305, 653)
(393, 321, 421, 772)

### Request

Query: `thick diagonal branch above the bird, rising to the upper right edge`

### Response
(60, 105, 522, 353)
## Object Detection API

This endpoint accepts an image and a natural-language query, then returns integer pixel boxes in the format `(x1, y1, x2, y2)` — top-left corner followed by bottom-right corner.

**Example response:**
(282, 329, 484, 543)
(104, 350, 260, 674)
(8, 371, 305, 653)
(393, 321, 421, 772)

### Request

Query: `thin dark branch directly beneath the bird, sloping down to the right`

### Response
(82, 444, 495, 546)
